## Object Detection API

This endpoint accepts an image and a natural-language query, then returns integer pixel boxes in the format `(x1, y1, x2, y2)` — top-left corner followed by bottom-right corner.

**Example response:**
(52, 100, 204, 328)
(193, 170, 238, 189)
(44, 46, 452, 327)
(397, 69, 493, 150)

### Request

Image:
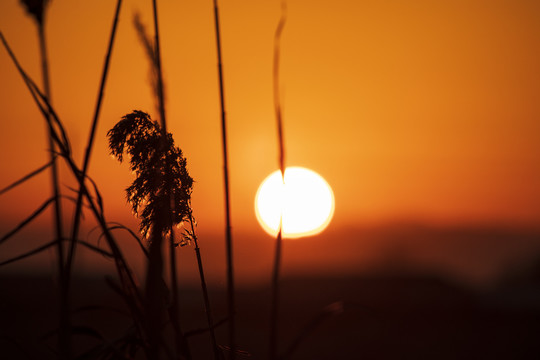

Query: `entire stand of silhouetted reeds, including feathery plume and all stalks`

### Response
(0, 0, 346, 360)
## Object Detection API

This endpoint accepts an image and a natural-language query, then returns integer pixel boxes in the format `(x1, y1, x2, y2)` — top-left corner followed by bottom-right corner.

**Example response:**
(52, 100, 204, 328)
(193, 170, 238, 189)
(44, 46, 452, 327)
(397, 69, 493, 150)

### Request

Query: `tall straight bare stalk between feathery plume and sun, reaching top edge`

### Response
(214, 0, 236, 360)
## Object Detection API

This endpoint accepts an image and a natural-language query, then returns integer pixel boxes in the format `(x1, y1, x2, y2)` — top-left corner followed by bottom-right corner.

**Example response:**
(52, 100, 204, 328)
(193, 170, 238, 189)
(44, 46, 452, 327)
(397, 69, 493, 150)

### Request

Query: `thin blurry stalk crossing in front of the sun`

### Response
(270, 0, 287, 360)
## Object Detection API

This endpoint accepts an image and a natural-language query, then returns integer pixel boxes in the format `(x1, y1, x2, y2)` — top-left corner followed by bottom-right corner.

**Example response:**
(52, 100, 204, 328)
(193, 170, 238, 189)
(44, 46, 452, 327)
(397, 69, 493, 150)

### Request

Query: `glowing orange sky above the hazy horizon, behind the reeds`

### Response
(0, 0, 540, 286)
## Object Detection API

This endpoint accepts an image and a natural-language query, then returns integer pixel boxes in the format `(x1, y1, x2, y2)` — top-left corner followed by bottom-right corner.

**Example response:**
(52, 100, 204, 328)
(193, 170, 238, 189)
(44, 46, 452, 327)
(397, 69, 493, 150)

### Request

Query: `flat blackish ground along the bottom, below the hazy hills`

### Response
(0, 274, 540, 360)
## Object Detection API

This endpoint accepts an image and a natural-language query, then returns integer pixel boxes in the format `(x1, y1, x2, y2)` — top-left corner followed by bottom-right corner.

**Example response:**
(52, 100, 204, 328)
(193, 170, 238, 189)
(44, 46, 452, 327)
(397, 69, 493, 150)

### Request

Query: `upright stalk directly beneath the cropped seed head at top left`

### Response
(38, 16, 71, 360)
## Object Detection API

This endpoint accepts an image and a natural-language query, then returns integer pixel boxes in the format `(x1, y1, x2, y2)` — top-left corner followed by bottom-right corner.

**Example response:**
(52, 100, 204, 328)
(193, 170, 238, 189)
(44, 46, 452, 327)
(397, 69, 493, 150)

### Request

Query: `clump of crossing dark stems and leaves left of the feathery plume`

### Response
(0, 0, 152, 359)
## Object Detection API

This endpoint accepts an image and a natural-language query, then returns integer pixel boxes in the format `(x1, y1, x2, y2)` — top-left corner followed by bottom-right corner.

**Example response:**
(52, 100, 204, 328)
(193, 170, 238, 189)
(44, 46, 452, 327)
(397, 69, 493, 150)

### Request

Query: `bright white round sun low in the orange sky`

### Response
(255, 167, 334, 238)
